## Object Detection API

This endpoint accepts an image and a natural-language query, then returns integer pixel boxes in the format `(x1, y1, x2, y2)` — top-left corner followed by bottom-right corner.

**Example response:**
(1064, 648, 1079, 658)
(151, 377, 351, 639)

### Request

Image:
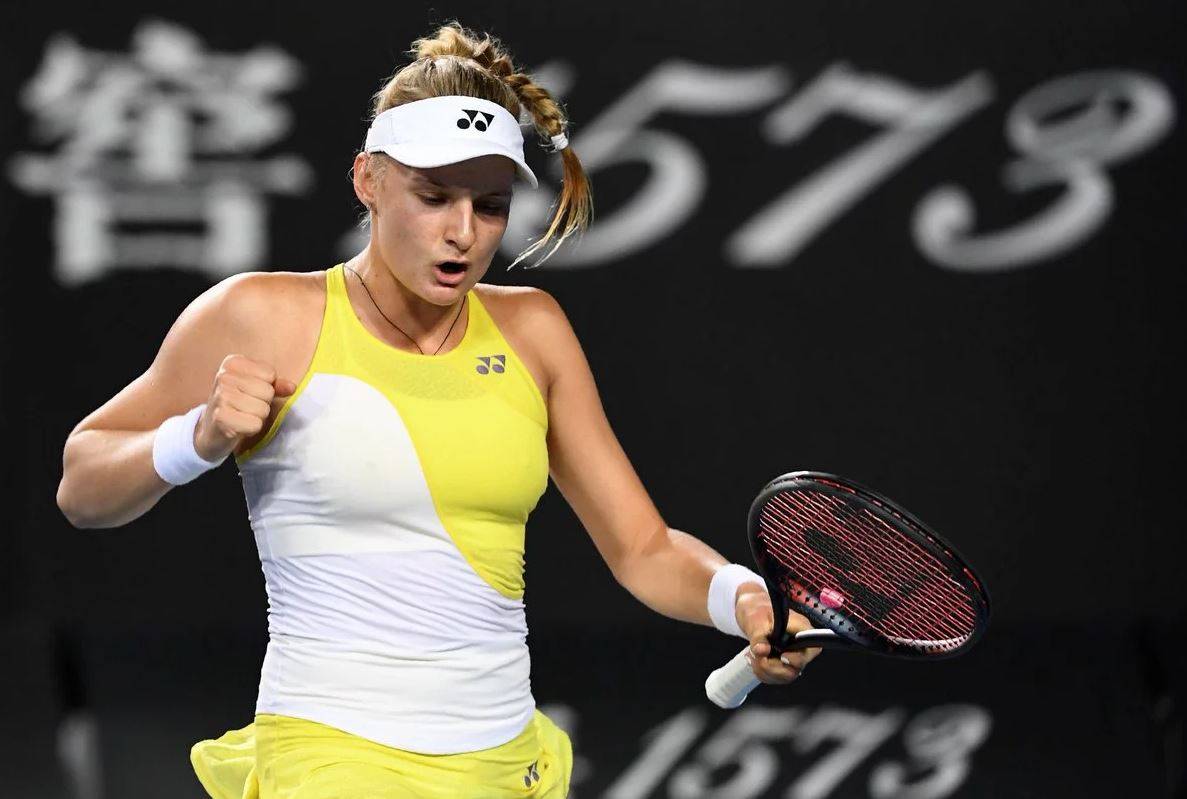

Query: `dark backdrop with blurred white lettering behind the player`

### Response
(0, 0, 1187, 799)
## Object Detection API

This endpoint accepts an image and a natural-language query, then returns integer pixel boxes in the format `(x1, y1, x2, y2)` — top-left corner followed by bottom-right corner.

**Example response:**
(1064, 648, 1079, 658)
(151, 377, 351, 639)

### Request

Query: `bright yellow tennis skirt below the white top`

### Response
(190, 710, 573, 799)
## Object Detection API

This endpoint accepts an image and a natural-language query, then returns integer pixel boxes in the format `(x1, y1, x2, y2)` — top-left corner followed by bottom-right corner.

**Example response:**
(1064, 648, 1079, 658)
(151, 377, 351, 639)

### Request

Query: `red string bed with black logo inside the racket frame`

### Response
(760, 490, 977, 649)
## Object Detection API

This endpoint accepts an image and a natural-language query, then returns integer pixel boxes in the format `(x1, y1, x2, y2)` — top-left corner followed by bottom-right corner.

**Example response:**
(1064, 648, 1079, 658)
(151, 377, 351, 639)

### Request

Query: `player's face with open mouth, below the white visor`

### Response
(355, 153, 515, 305)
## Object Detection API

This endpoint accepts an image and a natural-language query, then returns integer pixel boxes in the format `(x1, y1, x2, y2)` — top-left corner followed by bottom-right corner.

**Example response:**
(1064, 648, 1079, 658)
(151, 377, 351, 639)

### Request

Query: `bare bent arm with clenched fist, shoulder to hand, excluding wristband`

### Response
(57, 273, 292, 527)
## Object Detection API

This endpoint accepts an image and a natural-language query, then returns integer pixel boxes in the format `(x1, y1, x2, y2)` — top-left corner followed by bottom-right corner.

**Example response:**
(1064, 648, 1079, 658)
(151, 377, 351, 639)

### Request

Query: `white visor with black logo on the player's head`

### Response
(363, 95, 539, 189)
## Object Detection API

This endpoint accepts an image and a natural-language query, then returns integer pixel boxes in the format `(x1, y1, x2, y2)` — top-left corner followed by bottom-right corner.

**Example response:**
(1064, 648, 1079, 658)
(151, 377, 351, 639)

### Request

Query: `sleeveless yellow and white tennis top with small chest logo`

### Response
(236, 264, 548, 754)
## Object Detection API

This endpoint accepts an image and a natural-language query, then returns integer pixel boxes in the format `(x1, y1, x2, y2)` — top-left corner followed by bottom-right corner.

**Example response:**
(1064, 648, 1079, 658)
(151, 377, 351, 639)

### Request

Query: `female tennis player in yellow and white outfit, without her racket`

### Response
(58, 23, 815, 799)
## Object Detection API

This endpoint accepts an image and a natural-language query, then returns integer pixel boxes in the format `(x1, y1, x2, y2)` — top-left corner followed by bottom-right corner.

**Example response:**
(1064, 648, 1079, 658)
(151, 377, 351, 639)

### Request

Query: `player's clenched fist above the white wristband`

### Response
(193, 355, 297, 461)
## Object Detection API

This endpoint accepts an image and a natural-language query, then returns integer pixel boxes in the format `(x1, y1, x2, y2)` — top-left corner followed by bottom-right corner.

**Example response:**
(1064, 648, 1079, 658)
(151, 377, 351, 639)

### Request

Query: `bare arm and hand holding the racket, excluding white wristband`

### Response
(526, 291, 819, 683)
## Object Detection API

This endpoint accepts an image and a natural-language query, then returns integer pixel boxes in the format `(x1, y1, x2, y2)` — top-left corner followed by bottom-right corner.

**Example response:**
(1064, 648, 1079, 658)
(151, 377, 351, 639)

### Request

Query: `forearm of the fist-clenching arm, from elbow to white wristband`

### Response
(57, 430, 172, 528)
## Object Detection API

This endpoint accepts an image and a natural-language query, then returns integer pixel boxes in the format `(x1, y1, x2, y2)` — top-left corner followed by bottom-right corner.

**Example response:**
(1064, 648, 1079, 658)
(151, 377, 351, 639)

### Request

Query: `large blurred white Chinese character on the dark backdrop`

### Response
(8, 20, 313, 285)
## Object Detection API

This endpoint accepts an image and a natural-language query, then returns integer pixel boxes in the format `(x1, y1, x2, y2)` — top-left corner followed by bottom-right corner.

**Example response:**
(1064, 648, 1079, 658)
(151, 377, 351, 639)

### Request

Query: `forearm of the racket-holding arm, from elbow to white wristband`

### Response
(615, 526, 726, 627)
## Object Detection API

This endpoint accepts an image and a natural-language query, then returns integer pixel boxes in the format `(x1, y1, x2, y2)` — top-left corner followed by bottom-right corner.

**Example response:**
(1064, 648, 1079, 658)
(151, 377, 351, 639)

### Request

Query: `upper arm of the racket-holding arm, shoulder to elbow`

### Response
(540, 296, 665, 573)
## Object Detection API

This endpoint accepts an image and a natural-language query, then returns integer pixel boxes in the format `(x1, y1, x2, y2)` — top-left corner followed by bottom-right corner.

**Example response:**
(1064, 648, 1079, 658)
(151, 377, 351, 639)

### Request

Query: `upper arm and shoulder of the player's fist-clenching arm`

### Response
(71, 274, 271, 435)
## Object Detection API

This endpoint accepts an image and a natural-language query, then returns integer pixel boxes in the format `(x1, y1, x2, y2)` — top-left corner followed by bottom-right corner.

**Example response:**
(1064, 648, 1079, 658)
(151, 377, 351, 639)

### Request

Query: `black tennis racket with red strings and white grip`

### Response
(705, 471, 989, 708)
